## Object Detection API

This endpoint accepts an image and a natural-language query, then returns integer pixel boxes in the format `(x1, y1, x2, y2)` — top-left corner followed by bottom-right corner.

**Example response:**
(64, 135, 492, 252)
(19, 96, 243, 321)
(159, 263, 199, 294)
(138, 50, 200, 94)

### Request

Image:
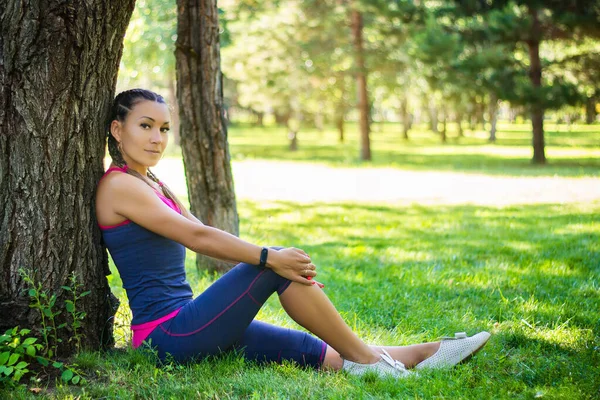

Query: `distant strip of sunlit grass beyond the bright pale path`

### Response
(212, 123, 600, 177)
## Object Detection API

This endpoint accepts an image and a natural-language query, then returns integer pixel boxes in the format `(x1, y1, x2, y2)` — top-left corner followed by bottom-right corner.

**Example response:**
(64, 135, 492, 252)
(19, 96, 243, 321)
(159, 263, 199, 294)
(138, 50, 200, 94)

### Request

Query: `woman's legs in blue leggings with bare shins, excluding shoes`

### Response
(149, 264, 436, 369)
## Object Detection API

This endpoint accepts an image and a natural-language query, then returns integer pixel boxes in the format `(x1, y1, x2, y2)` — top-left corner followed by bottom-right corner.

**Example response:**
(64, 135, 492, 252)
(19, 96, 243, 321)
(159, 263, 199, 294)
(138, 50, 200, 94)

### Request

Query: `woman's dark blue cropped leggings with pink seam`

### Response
(146, 263, 327, 369)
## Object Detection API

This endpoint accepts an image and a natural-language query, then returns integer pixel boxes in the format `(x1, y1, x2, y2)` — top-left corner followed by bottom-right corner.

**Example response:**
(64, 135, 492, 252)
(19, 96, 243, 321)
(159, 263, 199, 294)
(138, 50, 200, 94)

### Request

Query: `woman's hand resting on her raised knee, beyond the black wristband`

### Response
(267, 247, 317, 285)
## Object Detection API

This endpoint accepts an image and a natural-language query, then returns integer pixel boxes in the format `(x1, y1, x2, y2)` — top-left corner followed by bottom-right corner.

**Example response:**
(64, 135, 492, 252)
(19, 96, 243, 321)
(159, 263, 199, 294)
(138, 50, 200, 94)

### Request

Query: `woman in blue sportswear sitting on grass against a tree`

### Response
(96, 89, 490, 377)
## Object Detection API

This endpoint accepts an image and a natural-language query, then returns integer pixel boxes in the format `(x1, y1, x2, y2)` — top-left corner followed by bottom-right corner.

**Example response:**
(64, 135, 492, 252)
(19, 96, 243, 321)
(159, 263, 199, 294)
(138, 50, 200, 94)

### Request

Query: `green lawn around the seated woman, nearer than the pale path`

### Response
(7, 202, 600, 399)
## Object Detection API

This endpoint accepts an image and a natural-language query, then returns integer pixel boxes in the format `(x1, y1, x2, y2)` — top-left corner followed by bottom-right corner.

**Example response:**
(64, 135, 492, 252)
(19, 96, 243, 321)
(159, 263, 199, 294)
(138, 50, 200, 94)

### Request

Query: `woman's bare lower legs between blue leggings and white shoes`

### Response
(279, 282, 439, 369)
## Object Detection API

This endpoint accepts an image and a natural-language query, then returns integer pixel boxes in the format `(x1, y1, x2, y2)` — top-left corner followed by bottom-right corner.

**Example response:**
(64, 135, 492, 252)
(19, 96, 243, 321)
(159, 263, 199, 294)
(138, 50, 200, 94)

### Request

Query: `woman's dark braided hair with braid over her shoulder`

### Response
(107, 89, 183, 210)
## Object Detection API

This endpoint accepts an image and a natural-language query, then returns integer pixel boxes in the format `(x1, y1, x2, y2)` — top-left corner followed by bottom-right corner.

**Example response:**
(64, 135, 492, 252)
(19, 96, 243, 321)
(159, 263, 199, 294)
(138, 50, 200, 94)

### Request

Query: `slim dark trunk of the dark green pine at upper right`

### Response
(527, 6, 546, 164)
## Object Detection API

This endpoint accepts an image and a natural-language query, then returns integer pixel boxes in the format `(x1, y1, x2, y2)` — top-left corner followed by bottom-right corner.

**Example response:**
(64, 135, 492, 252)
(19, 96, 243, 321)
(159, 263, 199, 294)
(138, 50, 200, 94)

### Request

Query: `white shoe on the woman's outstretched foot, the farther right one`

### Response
(415, 332, 491, 369)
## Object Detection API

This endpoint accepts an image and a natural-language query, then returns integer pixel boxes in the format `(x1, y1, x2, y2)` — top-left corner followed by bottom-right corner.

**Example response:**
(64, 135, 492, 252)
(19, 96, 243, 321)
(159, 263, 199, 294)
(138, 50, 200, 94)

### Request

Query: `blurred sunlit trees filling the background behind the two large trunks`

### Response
(117, 0, 600, 170)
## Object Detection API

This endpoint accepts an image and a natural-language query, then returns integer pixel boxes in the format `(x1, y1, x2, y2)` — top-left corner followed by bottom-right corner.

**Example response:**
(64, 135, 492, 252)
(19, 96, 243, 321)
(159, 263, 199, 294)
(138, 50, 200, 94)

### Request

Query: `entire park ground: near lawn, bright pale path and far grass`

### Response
(5, 124, 600, 399)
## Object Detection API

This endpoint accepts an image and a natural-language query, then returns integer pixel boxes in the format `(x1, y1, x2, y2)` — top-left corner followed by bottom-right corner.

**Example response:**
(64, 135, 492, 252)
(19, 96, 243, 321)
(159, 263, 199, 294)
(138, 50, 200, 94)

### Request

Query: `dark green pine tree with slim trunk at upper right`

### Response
(449, 0, 600, 164)
